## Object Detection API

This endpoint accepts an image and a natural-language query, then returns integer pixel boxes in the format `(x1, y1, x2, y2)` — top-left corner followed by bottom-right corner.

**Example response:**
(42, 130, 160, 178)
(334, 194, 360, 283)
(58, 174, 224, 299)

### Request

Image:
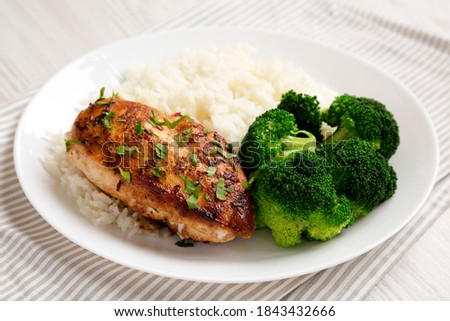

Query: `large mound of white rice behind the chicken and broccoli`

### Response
(116, 43, 336, 142)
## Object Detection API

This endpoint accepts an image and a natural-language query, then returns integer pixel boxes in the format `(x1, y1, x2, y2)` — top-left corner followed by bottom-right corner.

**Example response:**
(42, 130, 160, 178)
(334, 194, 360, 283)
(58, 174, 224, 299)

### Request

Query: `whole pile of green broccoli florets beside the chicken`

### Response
(240, 90, 399, 247)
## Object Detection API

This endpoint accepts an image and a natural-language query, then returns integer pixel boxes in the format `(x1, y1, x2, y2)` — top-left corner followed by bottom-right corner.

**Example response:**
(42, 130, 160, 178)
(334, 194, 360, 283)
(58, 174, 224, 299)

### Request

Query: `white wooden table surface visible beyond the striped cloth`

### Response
(0, 0, 450, 300)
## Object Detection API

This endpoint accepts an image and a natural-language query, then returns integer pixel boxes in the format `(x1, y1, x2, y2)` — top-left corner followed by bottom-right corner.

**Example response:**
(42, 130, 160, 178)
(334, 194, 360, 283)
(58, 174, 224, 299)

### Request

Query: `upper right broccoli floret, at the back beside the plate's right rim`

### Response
(322, 94, 400, 159)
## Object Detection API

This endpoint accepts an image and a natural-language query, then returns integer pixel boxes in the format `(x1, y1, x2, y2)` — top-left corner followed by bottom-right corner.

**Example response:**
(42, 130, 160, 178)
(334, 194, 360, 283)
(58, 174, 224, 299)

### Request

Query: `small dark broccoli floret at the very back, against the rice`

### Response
(278, 90, 323, 142)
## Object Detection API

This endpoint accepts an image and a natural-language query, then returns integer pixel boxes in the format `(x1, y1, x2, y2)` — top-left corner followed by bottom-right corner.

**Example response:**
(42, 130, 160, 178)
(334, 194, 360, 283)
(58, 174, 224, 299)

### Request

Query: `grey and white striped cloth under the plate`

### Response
(0, 0, 450, 300)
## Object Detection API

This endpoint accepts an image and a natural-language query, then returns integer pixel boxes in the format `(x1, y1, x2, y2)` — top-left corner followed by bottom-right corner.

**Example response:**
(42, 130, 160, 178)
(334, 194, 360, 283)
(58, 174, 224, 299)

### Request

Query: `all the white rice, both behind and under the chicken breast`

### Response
(49, 43, 336, 237)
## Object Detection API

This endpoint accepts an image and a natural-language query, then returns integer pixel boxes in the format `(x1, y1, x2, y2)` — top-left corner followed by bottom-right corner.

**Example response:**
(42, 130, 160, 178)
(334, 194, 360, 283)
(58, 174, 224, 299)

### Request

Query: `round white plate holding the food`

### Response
(14, 30, 438, 282)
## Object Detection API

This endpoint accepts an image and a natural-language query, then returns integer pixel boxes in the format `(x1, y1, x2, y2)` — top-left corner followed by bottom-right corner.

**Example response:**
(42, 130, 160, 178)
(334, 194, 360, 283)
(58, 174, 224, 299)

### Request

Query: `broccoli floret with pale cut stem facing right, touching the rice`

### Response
(239, 108, 316, 173)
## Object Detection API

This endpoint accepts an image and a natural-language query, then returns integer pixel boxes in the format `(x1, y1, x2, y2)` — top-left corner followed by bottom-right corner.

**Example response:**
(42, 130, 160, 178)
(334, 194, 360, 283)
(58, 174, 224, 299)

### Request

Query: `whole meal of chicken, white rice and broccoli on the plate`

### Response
(55, 44, 399, 247)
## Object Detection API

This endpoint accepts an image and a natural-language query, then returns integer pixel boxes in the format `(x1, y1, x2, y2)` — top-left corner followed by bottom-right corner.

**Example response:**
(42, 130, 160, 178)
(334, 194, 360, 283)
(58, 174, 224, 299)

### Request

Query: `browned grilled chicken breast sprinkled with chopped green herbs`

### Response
(67, 97, 255, 243)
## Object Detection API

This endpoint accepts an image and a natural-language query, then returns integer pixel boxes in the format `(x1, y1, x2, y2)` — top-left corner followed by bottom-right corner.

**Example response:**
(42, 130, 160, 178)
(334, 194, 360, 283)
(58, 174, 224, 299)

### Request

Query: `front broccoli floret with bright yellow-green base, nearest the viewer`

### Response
(251, 151, 353, 247)
